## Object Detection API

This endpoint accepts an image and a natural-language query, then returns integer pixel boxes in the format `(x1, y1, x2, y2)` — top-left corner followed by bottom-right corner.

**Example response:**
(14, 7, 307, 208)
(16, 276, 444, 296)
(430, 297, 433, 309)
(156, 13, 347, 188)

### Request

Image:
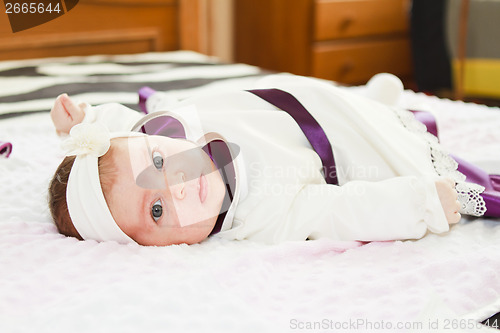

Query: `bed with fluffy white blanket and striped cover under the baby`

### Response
(0, 51, 500, 333)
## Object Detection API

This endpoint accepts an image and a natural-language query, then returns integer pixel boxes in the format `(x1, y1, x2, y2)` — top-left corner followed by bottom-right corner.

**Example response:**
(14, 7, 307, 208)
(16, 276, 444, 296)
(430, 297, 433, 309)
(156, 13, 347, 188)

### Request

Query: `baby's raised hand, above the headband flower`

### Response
(50, 94, 85, 134)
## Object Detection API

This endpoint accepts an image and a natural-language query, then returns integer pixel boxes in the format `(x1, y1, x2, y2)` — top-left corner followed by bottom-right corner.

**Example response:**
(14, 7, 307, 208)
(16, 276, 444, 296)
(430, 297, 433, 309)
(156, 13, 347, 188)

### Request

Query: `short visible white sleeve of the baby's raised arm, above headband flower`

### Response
(83, 103, 144, 132)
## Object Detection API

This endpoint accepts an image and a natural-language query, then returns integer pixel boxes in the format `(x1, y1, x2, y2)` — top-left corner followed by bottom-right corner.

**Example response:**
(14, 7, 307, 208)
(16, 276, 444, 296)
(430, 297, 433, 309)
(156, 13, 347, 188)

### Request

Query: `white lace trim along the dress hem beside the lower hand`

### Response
(394, 108, 486, 216)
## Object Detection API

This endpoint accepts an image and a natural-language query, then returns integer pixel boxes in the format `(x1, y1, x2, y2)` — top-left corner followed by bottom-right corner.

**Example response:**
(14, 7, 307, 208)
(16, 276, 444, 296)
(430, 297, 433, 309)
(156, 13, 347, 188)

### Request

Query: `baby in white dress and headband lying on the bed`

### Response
(49, 75, 484, 246)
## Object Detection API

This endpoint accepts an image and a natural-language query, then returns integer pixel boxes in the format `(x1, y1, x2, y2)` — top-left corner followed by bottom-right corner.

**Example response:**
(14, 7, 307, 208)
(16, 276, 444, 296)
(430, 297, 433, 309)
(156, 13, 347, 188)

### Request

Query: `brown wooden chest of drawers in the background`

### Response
(235, 0, 412, 84)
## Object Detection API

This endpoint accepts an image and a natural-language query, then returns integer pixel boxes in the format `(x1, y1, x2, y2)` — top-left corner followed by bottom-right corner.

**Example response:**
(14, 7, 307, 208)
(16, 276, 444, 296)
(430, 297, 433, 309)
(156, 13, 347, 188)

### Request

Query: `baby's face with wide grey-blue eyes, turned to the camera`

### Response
(106, 136, 225, 246)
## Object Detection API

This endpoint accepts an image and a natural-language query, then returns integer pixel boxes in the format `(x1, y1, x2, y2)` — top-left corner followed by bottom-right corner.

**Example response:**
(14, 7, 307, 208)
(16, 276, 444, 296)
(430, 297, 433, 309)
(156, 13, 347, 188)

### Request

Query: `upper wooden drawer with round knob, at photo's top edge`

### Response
(314, 0, 410, 41)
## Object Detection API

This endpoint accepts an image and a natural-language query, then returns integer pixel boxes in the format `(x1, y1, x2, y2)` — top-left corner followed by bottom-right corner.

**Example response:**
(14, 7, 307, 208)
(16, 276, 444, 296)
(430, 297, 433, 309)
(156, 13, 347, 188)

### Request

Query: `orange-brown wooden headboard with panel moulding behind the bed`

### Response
(0, 0, 204, 60)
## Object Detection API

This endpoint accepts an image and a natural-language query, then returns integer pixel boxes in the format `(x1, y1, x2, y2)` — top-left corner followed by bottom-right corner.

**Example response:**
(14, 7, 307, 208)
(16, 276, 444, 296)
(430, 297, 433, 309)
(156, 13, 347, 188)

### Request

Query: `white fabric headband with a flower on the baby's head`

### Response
(63, 123, 144, 244)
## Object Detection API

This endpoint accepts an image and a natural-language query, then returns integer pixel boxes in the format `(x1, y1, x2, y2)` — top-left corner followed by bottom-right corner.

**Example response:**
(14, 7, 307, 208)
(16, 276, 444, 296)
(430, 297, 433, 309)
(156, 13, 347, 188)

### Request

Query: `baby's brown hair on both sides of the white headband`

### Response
(48, 140, 120, 240)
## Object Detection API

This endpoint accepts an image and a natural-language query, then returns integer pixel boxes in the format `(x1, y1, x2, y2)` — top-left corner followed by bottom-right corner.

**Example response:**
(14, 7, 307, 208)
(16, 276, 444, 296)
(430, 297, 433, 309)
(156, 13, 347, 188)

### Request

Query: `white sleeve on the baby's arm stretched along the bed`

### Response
(289, 176, 449, 241)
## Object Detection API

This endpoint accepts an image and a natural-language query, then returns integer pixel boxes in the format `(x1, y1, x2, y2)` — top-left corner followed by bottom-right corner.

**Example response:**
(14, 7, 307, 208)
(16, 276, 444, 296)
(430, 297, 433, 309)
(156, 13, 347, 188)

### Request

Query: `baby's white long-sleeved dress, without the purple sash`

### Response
(85, 75, 460, 243)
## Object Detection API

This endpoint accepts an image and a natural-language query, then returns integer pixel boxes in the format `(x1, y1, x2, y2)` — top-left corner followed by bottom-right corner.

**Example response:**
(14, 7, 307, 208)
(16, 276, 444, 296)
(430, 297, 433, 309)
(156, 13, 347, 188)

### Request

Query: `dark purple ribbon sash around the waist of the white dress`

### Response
(249, 89, 339, 185)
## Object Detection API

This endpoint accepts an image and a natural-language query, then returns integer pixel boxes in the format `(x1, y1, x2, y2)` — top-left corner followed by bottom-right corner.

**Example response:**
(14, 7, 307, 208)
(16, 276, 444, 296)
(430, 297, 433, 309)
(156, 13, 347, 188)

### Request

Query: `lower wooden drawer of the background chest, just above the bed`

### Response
(312, 38, 412, 84)
